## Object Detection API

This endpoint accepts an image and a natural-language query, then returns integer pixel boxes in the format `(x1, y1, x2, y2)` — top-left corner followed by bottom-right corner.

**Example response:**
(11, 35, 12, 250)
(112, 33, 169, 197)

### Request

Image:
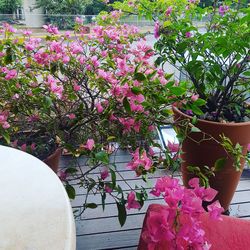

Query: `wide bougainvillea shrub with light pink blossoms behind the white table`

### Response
(0, 12, 201, 225)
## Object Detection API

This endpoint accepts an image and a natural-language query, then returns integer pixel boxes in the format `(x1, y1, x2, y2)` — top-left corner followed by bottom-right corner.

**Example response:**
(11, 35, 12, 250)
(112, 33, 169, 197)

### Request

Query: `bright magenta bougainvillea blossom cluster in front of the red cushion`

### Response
(142, 177, 223, 250)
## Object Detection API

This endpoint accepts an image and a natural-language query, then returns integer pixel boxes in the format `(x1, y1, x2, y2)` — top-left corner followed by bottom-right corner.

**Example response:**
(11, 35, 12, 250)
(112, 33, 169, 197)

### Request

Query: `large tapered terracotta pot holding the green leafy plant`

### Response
(173, 108, 250, 210)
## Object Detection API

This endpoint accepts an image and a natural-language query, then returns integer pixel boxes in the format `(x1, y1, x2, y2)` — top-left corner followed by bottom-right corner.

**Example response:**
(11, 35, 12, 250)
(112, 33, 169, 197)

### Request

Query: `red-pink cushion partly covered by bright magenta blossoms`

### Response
(138, 204, 250, 250)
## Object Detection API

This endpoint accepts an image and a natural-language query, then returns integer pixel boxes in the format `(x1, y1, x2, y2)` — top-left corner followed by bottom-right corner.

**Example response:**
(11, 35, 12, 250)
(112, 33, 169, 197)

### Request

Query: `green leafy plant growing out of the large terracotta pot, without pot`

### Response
(114, 0, 250, 122)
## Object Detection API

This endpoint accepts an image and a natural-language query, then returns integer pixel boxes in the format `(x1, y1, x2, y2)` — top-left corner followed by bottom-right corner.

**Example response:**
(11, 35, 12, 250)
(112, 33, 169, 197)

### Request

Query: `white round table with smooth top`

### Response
(0, 146, 76, 250)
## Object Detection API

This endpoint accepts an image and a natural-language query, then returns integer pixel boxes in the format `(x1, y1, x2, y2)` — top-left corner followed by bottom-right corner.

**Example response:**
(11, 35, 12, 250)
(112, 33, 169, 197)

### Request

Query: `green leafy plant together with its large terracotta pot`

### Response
(114, 0, 250, 212)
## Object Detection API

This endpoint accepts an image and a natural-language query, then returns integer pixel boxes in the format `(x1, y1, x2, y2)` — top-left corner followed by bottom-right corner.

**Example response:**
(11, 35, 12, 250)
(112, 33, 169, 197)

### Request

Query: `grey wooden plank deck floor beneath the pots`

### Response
(60, 152, 250, 250)
